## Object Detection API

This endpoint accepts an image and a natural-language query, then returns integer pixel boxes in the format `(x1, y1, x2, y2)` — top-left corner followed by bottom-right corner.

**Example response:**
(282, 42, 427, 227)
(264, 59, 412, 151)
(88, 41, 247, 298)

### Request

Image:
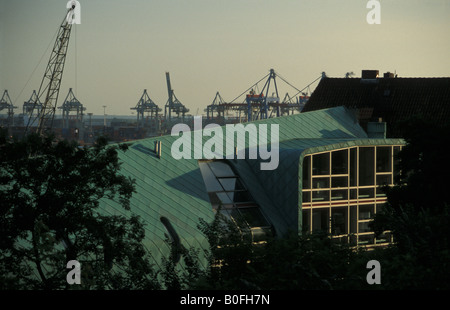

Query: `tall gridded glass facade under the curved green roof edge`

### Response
(301, 145, 401, 245)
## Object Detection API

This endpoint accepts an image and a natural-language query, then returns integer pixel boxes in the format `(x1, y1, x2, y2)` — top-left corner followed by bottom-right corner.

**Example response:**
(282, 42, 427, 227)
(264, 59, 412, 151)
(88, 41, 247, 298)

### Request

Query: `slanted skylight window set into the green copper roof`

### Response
(199, 161, 270, 241)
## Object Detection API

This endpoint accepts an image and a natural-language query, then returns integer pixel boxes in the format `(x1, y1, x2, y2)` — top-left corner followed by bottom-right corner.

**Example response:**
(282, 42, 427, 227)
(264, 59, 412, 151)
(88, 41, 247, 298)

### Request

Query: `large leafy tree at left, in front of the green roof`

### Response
(0, 132, 159, 289)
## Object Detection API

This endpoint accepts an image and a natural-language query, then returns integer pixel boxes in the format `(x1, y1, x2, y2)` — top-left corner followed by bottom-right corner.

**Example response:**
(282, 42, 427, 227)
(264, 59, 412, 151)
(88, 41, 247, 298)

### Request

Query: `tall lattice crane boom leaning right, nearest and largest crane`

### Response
(25, 1, 77, 135)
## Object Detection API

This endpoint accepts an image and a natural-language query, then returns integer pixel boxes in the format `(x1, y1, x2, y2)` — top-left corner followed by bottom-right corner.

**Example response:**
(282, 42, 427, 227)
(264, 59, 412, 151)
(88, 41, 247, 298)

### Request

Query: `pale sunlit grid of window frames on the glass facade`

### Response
(300, 144, 404, 246)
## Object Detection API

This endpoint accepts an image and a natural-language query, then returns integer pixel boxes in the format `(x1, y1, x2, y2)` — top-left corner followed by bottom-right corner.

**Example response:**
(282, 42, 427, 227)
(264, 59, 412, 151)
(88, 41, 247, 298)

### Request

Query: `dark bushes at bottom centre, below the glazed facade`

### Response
(184, 212, 370, 290)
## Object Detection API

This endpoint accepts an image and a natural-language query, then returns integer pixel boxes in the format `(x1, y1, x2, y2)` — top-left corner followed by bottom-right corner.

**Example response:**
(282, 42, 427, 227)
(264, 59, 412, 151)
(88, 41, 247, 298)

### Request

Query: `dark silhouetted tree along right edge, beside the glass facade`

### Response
(374, 118, 450, 289)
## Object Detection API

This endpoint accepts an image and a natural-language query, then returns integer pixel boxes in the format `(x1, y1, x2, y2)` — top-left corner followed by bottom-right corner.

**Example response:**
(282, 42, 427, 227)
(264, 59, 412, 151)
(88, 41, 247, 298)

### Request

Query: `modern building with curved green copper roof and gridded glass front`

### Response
(101, 107, 404, 265)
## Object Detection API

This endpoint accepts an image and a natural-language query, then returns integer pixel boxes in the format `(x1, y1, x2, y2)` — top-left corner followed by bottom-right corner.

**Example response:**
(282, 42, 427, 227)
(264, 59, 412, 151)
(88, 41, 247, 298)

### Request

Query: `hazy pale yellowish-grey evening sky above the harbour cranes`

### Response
(0, 0, 450, 115)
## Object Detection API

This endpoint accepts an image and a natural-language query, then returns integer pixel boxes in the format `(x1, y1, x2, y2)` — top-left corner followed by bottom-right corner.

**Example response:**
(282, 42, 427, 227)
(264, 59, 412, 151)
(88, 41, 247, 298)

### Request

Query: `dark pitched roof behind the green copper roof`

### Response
(303, 77, 450, 137)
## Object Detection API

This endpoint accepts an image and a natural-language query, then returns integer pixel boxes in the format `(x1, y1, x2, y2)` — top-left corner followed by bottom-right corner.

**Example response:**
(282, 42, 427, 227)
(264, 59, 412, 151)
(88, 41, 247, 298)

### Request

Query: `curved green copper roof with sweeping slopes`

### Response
(98, 107, 400, 268)
